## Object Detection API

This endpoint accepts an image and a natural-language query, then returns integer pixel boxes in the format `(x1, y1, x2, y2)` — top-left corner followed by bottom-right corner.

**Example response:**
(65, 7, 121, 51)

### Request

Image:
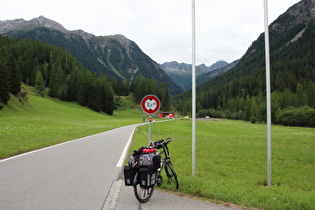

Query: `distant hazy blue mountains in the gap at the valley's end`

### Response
(160, 61, 233, 91)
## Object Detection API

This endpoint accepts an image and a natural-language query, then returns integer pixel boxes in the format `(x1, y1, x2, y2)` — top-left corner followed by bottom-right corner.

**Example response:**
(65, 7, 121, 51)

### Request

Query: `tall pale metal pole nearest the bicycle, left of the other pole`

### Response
(191, 0, 196, 176)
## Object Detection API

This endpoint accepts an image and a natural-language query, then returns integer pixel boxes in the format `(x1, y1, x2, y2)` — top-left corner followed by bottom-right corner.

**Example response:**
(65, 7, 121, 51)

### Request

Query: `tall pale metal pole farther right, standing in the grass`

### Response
(264, 0, 272, 186)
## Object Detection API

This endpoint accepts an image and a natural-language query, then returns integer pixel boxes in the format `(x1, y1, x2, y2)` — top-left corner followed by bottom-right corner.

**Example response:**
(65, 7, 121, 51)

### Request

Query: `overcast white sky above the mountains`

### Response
(0, 0, 299, 66)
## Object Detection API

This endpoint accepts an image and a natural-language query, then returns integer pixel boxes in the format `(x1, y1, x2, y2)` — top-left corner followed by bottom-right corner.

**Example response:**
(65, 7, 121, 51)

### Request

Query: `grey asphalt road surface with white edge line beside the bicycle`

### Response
(0, 125, 242, 210)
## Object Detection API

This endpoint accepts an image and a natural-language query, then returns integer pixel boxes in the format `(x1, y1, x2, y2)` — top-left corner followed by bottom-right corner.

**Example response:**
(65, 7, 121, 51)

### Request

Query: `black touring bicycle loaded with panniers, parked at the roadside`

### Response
(124, 138, 179, 203)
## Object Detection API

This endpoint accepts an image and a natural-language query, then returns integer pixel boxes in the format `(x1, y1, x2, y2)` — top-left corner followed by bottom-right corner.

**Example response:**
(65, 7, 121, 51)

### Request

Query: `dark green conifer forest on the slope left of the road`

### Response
(0, 35, 169, 115)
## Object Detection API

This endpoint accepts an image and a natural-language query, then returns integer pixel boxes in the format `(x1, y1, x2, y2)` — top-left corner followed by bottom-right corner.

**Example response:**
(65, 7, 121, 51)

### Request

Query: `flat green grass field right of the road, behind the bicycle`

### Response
(130, 120, 315, 209)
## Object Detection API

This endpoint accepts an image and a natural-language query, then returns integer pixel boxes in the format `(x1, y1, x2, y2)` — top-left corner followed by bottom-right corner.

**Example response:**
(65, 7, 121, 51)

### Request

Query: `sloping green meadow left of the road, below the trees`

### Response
(0, 91, 142, 159)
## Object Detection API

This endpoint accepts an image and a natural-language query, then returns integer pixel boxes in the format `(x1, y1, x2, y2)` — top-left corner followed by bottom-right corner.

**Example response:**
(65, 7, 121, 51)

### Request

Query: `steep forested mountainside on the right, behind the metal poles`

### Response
(174, 0, 315, 126)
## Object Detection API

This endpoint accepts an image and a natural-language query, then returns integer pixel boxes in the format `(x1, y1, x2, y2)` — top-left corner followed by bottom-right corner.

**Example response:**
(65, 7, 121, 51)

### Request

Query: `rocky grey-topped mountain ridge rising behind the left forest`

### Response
(0, 16, 182, 95)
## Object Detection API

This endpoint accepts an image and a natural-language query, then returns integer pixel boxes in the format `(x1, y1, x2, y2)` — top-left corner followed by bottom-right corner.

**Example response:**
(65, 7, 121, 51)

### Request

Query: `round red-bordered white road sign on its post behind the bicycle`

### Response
(141, 95, 161, 143)
